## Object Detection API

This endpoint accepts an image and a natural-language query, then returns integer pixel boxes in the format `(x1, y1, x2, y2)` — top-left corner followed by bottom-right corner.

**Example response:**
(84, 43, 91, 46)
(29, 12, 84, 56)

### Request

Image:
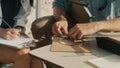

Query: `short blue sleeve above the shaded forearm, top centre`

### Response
(53, 0, 69, 11)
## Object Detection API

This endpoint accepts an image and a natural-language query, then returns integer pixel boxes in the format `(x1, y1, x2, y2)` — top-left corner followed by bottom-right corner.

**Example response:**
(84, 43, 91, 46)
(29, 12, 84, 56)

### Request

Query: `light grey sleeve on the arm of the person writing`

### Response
(14, 2, 31, 27)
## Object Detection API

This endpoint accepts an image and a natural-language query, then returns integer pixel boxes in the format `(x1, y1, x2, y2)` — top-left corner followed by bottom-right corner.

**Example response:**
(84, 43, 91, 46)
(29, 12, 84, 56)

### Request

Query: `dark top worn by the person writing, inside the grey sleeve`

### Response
(1, 0, 21, 28)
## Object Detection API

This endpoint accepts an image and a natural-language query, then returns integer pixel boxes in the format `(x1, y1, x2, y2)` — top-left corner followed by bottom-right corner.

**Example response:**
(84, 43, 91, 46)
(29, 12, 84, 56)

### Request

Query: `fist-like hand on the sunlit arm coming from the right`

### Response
(69, 23, 98, 39)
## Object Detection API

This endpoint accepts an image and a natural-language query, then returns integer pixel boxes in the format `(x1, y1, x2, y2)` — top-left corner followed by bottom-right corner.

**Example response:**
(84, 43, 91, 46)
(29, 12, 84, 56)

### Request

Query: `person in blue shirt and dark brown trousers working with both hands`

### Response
(31, 0, 120, 66)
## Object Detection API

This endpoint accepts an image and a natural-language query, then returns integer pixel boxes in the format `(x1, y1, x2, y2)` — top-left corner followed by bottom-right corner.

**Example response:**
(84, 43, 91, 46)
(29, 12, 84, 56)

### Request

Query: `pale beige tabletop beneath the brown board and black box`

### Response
(30, 37, 116, 68)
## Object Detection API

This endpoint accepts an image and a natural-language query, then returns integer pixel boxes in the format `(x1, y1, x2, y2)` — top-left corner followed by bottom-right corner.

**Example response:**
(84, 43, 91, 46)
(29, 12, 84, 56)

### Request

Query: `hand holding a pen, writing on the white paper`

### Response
(0, 28, 20, 40)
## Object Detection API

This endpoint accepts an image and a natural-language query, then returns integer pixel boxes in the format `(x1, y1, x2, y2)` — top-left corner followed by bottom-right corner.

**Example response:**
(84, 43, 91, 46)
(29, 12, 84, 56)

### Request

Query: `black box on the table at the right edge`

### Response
(96, 37, 120, 55)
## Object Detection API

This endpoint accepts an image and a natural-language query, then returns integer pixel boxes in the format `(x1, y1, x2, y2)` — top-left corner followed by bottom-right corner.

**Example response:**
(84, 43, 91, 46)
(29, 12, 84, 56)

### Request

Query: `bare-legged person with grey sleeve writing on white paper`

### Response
(0, 0, 43, 68)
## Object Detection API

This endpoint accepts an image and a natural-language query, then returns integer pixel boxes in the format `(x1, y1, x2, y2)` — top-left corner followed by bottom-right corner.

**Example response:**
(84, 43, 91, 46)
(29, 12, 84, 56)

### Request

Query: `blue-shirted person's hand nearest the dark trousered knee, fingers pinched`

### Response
(52, 20, 68, 36)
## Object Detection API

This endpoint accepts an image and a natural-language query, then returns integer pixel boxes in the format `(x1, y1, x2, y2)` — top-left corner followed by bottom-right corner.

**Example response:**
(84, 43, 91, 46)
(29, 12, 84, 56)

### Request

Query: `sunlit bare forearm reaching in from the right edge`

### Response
(96, 18, 120, 31)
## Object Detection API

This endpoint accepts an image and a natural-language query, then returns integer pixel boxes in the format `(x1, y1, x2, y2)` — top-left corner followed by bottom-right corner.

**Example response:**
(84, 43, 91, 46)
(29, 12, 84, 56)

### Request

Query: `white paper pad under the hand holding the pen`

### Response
(0, 36, 34, 49)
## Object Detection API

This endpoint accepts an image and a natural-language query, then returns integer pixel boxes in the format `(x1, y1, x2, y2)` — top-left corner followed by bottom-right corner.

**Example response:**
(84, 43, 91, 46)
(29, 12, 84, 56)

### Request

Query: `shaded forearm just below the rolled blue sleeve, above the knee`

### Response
(53, 6, 67, 21)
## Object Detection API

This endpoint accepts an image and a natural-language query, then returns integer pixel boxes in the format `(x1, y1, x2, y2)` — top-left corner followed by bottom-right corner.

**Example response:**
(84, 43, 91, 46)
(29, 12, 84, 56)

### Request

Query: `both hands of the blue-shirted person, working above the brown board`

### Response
(52, 20, 98, 39)
